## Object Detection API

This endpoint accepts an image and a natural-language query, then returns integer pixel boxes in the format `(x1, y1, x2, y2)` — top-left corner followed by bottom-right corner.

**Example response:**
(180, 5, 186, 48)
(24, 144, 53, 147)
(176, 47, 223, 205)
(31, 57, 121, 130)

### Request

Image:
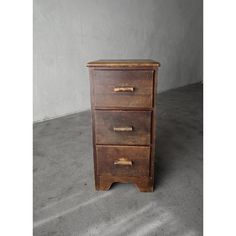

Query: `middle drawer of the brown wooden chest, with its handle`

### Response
(94, 110, 152, 145)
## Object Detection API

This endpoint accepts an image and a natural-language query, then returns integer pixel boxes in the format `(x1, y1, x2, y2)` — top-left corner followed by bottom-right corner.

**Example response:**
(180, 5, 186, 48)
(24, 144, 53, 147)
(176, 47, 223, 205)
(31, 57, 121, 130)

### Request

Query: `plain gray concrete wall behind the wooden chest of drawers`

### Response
(34, 0, 202, 121)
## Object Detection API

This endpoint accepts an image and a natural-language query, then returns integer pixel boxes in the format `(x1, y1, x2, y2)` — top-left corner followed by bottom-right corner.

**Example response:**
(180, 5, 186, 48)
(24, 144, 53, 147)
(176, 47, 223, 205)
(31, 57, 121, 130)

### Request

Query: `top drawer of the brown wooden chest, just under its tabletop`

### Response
(93, 70, 153, 108)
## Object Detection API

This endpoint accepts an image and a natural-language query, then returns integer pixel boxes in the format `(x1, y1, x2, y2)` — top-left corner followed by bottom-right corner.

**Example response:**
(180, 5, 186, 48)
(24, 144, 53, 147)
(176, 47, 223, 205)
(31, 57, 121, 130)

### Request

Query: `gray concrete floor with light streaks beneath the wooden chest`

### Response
(33, 84, 203, 236)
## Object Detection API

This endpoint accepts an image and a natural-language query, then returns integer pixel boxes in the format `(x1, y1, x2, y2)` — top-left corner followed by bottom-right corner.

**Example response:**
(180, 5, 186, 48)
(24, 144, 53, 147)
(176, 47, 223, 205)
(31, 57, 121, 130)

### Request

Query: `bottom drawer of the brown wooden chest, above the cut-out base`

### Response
(96, 146, 150, 176)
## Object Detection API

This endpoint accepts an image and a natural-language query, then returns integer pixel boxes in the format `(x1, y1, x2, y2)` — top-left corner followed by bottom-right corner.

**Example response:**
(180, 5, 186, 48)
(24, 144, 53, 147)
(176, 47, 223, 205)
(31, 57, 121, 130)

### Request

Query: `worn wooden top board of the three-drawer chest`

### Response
(87, 59, 160, 67)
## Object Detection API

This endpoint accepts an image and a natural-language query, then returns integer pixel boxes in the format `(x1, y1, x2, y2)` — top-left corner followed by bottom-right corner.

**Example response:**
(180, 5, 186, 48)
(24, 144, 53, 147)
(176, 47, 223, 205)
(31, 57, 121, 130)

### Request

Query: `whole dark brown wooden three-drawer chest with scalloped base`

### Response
(87, 60, 160, 192)
